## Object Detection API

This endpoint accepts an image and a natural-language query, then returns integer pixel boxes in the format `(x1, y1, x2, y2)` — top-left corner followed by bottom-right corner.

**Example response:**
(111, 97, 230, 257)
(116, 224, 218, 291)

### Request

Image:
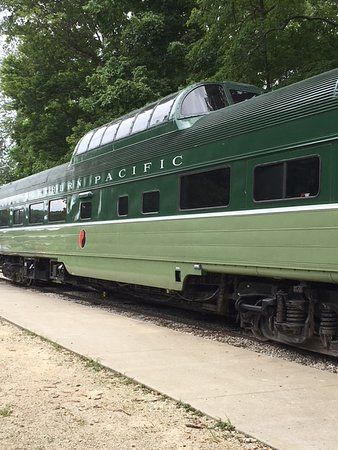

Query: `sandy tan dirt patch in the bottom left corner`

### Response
(0, 321, 267, 450)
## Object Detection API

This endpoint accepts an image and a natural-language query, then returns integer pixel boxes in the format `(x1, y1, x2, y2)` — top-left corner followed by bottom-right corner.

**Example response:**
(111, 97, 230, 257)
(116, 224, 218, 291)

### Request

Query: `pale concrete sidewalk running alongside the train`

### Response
(0, 280, 338, 450)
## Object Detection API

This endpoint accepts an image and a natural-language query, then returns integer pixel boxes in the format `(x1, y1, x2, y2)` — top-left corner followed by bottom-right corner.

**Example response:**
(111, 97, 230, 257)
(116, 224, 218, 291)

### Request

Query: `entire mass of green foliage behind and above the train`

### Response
(0, 0, 338, 179)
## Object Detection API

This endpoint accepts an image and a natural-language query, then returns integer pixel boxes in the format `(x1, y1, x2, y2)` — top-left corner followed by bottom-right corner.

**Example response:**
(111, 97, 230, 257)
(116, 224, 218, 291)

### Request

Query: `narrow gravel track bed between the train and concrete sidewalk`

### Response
(0, 277, 338, 373)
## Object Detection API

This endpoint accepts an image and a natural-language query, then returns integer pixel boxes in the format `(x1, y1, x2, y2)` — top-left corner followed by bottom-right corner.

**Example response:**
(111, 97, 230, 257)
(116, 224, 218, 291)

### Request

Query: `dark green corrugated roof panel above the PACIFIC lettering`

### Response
(72, 69, 338, 175)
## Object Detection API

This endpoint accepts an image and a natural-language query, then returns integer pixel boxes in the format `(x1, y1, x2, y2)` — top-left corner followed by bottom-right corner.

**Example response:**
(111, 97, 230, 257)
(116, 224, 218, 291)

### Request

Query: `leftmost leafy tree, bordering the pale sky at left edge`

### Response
(1, 0, 101, 178)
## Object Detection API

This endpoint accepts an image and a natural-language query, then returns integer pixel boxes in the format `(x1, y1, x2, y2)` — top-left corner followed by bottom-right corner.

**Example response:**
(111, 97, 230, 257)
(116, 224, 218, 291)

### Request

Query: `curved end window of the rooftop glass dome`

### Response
(181, 84, 228, 116)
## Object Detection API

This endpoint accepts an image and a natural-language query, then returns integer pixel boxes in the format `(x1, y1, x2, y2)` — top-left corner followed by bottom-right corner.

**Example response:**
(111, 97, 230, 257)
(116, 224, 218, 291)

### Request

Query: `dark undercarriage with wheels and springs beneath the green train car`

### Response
(0, 256, 338, 357)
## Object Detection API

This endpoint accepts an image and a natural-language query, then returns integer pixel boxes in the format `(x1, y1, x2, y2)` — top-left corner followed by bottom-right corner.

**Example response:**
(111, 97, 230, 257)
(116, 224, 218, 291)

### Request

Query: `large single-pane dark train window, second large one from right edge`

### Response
(180, 167, 230, 209)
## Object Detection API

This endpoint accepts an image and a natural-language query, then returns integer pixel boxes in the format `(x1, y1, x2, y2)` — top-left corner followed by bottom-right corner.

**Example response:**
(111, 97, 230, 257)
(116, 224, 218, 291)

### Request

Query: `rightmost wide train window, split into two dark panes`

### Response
(254, 156, 320, 201)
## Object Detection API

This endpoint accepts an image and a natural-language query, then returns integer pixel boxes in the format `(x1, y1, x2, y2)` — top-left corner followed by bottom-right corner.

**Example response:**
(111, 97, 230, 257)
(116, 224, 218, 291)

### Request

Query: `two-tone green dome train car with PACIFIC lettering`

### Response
(0, 69, 338, 356)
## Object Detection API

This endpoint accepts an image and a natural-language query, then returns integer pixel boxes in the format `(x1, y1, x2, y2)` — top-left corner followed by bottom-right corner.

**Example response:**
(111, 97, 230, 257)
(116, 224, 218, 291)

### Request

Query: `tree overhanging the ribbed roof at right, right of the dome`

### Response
(188, 0, 338, 89)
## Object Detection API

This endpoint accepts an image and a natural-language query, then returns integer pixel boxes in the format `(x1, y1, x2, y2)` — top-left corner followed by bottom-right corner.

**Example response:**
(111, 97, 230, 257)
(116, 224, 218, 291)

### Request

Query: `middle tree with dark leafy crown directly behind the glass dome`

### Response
(68, 0, 195, 152)
